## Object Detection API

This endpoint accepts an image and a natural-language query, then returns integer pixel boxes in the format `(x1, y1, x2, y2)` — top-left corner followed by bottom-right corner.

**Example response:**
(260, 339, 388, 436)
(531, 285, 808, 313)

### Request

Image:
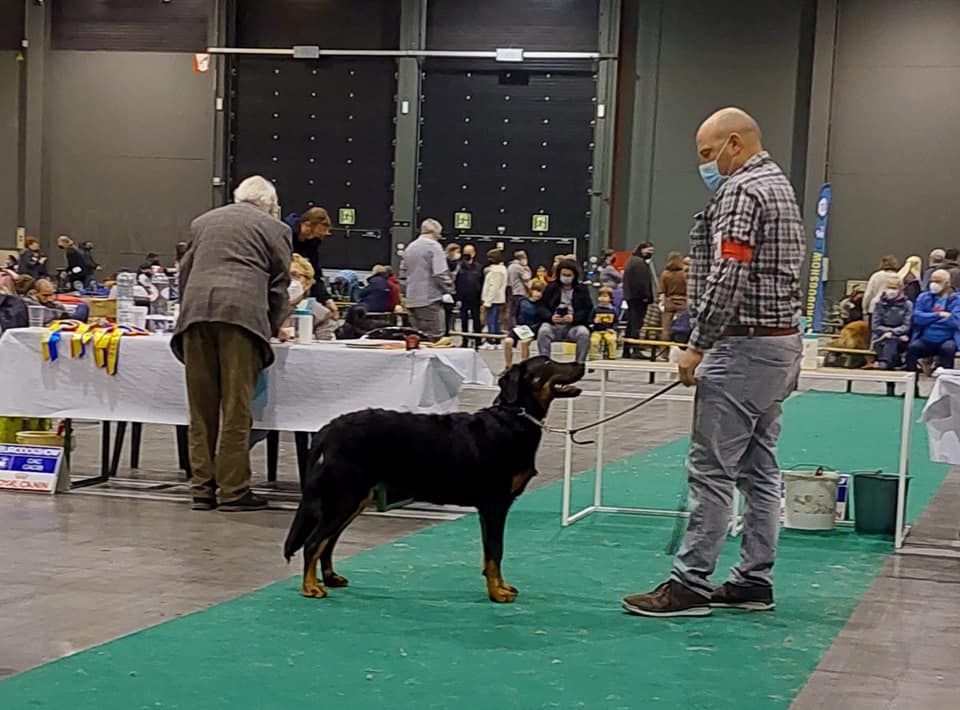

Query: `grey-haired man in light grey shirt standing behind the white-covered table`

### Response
(400, 219, 453, 338)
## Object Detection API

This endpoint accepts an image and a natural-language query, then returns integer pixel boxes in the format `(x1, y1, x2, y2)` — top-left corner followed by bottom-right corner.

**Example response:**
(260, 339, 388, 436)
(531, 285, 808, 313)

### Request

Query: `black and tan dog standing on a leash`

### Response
(283, 357, 584, 602)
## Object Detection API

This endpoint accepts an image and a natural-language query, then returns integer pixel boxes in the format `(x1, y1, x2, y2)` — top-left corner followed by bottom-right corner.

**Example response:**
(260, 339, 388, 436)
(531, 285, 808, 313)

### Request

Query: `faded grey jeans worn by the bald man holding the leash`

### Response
(671, 335, 803, 596)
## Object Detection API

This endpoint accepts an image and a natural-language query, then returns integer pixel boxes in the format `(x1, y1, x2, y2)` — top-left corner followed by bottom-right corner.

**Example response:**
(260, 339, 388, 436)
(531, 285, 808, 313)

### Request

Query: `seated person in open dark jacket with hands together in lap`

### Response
(537, 259, 593, 363)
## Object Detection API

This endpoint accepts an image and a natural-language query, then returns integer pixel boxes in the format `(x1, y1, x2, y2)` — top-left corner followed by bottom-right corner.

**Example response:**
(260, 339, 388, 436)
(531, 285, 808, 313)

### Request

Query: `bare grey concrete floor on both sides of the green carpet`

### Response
(0, 352, 960, 710)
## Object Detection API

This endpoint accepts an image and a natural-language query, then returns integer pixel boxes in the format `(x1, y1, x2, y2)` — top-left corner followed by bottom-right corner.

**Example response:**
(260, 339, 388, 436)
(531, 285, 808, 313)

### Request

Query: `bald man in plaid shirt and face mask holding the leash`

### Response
(623, 108, 805, 617)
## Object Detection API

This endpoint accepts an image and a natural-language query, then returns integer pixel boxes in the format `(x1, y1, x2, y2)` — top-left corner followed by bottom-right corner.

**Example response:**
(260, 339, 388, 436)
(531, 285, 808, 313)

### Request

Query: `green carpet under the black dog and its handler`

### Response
(0, 393, 947, 710)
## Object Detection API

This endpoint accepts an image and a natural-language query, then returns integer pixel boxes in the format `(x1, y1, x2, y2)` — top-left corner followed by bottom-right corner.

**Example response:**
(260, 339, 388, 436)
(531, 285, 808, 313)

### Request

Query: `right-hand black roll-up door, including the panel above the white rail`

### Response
(417, 0, 600, 261)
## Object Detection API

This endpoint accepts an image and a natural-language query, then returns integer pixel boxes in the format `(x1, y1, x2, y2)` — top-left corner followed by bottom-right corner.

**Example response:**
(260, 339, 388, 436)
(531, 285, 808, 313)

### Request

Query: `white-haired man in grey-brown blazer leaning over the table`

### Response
(171, 175, 291, 511)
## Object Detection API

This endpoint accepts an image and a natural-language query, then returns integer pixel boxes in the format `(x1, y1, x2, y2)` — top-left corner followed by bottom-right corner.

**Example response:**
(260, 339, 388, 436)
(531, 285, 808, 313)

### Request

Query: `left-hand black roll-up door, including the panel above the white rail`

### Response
(228, 0, 399, 269)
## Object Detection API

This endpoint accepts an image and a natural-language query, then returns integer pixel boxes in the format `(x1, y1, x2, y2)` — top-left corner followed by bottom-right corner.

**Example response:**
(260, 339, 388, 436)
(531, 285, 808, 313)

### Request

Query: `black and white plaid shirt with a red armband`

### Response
(688, 152, 806, 351)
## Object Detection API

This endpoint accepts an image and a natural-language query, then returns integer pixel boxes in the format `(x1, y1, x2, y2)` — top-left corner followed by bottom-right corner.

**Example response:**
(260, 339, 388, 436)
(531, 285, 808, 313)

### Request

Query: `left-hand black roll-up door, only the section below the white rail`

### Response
(230, 56, 395, 269)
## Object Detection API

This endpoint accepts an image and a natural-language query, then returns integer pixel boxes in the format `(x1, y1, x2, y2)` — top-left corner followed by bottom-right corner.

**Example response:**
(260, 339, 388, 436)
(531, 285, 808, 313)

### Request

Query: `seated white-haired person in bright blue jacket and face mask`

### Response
(907, 269, 960, 372)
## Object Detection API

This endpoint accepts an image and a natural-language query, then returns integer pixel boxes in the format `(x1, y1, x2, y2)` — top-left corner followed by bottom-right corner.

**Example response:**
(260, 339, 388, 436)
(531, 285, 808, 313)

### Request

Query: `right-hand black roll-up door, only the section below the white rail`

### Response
(419, 60, 596, 262)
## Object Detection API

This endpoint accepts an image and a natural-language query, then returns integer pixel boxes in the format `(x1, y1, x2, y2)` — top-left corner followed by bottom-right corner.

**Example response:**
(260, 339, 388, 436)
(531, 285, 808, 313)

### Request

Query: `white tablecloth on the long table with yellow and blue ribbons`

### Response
(0, 328, 493, 431)
